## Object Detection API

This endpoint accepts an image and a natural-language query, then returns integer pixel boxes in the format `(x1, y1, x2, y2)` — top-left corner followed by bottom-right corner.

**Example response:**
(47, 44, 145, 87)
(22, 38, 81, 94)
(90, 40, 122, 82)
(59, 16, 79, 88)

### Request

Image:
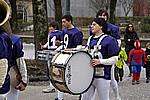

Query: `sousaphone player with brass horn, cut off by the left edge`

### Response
(0, 0, 12, 100)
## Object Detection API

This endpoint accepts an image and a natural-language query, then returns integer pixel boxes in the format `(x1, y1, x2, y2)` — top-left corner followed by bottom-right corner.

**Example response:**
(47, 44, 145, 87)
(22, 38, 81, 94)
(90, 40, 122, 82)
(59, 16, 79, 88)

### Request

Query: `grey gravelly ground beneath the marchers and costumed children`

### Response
(19, 67, 150, 100)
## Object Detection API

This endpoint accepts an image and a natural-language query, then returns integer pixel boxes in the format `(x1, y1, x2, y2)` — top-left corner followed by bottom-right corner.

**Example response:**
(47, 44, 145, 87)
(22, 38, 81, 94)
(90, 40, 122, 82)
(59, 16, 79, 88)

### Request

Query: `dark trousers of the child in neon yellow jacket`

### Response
(114, 67, 124, 82)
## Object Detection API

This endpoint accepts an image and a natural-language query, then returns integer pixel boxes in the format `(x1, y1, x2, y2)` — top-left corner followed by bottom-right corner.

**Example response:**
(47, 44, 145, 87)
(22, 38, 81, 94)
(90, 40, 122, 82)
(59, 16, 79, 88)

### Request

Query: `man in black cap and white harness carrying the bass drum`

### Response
(81, 18, 119, 100)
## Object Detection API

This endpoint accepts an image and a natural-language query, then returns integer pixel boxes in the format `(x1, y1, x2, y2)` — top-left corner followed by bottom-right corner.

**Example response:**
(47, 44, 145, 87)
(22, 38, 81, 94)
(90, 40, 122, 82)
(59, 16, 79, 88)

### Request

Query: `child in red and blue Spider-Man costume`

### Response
(128, 40, 146, 85)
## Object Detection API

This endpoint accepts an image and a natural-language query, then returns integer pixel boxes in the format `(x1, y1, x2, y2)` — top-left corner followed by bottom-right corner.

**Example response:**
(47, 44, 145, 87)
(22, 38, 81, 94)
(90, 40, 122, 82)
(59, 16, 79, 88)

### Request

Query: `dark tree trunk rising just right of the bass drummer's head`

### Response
(109, 0, 117, 23)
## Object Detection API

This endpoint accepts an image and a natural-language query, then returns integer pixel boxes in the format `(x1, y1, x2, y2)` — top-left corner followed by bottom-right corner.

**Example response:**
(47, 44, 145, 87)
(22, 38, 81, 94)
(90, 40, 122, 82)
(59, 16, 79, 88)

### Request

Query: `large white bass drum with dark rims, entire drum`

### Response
(50, 51, 95, 95)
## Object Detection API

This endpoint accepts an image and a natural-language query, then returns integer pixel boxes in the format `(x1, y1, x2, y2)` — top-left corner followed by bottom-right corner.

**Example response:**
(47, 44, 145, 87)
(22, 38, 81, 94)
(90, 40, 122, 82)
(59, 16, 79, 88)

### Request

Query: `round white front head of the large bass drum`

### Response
(65, 51, 94, 95)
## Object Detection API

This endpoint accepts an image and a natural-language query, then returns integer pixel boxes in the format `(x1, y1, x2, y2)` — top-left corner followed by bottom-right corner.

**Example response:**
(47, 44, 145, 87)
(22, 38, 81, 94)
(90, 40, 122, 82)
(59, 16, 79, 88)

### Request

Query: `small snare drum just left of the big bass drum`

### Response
(37, 50, 57, 60)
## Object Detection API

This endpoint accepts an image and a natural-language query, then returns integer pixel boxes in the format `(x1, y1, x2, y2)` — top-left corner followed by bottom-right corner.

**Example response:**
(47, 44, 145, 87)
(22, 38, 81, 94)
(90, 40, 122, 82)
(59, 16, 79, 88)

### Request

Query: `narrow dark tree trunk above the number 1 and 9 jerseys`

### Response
(54, 0, 62, 29)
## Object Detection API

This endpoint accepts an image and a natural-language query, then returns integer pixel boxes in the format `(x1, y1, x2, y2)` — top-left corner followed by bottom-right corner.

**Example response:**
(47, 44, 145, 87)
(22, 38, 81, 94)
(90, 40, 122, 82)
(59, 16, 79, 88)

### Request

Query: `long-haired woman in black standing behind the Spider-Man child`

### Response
(124, 23, 139, 77)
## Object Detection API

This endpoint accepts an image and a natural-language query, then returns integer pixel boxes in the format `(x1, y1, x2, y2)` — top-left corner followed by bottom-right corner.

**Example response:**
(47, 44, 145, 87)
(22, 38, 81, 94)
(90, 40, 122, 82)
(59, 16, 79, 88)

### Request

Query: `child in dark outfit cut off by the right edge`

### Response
(144, 42, 150, 83)
